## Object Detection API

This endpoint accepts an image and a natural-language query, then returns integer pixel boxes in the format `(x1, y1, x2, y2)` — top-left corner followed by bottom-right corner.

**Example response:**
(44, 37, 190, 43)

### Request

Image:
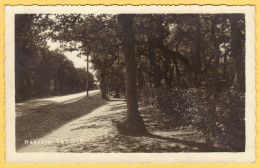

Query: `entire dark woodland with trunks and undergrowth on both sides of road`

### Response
(16, 14, 245, 151)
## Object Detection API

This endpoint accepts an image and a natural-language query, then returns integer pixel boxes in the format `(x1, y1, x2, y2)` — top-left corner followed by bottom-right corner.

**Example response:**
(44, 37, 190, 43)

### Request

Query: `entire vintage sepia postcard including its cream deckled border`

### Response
(5, 5, 256, 163)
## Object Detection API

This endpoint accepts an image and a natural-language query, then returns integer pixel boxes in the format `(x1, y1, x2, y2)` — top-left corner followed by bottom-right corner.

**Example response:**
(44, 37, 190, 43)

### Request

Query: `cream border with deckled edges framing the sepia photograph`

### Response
(5, 5, 256, 163)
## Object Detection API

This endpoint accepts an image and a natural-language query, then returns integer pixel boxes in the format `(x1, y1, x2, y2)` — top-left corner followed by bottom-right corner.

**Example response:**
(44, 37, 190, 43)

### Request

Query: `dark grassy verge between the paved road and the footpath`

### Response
(16, 94, 107, 149)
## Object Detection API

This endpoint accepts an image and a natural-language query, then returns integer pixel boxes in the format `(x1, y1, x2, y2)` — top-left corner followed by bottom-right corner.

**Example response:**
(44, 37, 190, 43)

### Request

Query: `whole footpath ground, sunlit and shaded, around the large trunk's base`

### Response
(17, 97, 228, 153)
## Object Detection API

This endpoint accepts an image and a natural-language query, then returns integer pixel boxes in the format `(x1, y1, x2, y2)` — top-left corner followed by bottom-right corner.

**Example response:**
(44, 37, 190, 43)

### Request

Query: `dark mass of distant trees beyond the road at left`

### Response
(15, 15, 94, 101)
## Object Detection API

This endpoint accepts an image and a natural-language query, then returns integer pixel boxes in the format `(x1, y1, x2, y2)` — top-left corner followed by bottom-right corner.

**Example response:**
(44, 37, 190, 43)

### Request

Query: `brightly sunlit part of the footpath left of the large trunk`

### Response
(18, 98, 126, 152)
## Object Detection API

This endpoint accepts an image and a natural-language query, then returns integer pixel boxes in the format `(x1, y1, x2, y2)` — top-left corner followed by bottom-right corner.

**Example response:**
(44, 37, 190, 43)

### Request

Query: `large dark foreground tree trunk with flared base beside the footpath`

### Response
(118, 14, 147, 135)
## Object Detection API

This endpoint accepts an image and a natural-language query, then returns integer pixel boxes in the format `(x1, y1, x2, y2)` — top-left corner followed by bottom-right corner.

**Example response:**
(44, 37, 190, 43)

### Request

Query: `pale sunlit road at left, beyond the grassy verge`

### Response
(15, 90, 100, 117)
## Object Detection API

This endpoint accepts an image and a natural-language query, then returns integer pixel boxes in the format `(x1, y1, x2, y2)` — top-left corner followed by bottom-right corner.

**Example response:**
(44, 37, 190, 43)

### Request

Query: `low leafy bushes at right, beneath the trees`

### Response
(140, 88, 245, 151)
